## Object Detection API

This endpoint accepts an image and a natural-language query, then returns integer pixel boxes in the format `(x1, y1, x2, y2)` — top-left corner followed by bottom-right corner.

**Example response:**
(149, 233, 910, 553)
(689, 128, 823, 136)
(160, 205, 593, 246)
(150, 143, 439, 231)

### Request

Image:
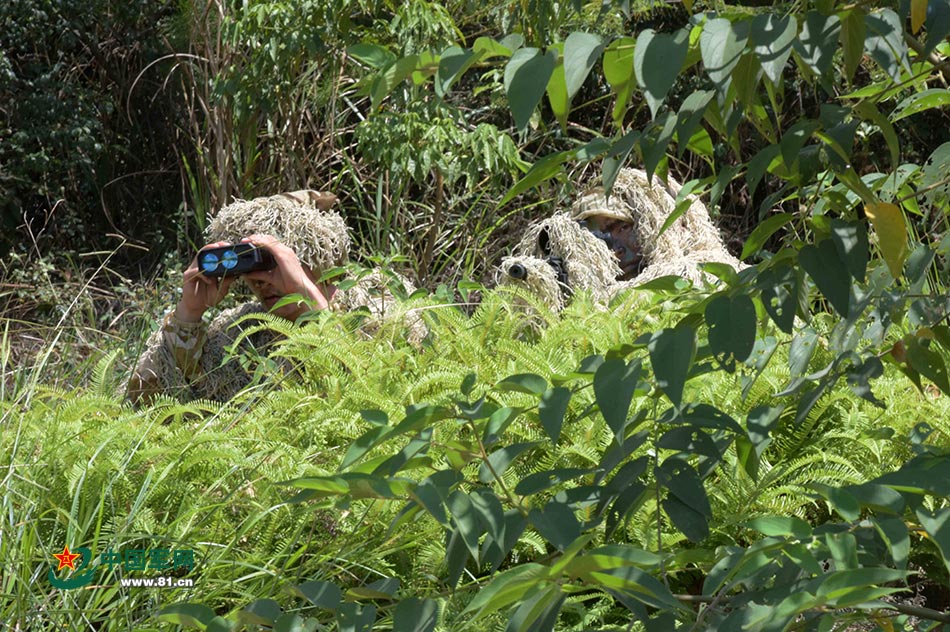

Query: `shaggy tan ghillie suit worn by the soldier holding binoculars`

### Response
(128, 191, 427, 401)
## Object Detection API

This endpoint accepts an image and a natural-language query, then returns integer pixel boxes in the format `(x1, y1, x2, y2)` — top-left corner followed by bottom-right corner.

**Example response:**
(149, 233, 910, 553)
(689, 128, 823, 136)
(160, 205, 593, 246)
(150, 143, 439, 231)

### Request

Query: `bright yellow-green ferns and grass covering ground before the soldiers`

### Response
(0, 266, 950, 630)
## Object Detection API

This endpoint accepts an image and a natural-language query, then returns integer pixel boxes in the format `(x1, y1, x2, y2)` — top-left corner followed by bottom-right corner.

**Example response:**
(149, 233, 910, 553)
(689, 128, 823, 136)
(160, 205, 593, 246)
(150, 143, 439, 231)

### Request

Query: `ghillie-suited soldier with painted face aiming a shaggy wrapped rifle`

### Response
(499, 168, 744, 309)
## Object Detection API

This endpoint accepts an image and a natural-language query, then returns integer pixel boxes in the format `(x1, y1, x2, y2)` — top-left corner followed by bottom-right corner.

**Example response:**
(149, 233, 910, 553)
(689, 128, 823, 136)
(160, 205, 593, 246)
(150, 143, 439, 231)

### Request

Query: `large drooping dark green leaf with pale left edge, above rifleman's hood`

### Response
(633, 29, 689, 118)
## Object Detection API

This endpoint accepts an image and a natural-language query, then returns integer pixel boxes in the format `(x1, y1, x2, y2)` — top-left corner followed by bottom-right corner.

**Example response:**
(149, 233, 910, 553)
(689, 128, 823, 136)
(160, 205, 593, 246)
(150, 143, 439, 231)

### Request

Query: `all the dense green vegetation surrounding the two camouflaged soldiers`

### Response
(0, 0, 950, 631)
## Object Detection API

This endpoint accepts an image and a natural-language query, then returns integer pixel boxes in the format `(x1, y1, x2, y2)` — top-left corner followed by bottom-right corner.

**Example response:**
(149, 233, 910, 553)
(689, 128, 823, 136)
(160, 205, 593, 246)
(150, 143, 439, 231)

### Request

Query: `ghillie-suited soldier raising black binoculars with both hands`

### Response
(128, 191, 425, 402)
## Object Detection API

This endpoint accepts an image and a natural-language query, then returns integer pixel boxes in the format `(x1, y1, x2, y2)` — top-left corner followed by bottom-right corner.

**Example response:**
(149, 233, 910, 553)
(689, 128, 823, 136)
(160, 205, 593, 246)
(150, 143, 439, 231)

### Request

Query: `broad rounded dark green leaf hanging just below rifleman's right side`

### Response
(705, 294, 756, 373)
